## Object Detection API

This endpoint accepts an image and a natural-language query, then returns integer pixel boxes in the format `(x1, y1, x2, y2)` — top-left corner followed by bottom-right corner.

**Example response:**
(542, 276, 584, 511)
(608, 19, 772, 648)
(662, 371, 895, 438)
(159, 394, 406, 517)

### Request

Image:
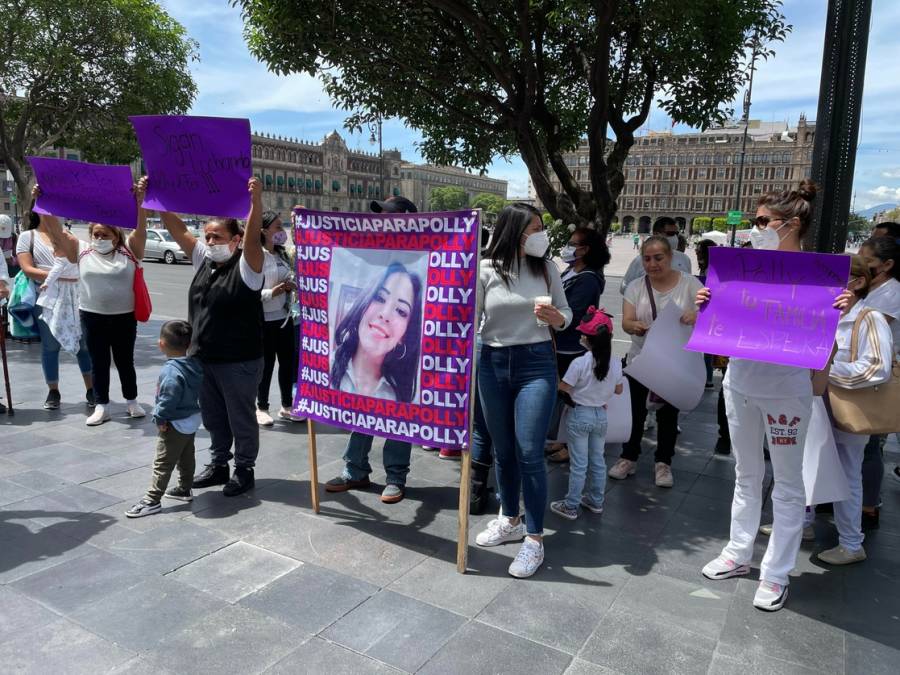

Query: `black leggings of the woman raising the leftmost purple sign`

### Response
(81, 310, 137, 405)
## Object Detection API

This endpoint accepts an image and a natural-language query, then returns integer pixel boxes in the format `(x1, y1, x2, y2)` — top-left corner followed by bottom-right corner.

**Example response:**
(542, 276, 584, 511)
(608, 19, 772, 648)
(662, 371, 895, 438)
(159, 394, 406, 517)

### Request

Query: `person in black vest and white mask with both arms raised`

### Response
(160, 178, 263, 497)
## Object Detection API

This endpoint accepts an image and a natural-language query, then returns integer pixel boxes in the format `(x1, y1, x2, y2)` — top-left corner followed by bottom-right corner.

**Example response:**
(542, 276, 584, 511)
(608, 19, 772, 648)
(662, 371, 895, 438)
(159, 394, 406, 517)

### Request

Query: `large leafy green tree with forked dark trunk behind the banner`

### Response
(233, 0, 789, 236)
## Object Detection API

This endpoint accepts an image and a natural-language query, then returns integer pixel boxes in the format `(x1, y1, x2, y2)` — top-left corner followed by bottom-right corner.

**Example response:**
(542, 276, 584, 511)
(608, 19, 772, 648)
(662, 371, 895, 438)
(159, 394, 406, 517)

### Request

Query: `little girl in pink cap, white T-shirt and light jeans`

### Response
(550, 306, 622, 520)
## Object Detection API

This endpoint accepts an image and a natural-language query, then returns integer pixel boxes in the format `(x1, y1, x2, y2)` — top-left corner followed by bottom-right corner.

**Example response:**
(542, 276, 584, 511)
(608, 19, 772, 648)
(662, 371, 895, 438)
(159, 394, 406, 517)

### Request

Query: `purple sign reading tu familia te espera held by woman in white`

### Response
(685, 247, 850, 370)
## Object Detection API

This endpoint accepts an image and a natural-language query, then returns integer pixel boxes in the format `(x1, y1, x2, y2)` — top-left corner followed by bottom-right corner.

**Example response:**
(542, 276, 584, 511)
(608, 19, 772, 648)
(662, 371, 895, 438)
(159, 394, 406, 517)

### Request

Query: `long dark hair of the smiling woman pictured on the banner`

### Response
(331, 262, 422, 403)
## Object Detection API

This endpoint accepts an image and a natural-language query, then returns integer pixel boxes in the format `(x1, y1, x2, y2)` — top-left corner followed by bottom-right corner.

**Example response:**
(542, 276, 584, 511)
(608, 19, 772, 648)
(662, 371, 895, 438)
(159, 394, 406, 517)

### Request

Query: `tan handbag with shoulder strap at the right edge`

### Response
(828, 309, 900, 435)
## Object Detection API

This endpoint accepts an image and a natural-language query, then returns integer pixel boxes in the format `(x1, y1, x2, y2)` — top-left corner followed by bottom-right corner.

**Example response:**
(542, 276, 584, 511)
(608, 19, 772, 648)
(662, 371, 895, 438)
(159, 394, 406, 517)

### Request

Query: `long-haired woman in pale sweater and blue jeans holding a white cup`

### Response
(475, 204, 572, 577)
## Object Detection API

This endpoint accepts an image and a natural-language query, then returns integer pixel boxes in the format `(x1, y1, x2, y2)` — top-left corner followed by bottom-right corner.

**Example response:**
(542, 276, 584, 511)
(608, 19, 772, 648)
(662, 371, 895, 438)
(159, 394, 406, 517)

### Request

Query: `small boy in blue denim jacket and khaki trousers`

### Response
(125, 321, 203, 518)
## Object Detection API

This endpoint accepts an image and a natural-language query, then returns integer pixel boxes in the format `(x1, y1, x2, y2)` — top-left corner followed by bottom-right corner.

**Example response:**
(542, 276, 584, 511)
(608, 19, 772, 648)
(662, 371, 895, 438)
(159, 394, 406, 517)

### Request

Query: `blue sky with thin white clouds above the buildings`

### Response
(162, 0, 900, 209)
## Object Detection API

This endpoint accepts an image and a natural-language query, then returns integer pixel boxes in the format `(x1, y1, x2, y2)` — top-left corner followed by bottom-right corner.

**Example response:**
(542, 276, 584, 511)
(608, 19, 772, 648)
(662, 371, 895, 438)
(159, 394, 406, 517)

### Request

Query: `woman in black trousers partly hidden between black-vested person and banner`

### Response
(256, 211, 297, 427)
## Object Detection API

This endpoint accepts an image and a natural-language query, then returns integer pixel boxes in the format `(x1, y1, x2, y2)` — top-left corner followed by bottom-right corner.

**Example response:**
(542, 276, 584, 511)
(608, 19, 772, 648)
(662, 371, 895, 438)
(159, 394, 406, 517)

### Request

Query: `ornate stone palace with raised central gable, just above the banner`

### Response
(251, 131, 401, 211)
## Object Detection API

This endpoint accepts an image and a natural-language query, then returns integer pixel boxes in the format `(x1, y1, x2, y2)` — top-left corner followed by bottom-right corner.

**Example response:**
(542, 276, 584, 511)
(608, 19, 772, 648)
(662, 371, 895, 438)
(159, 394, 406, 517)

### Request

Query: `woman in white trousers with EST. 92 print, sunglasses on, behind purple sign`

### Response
(697, 180, 849, 611)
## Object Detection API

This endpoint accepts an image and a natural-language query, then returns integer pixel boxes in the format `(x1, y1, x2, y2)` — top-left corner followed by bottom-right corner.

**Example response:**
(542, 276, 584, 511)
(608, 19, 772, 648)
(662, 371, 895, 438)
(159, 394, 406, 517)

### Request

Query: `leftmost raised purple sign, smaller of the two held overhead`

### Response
(27, 157, 137, 230)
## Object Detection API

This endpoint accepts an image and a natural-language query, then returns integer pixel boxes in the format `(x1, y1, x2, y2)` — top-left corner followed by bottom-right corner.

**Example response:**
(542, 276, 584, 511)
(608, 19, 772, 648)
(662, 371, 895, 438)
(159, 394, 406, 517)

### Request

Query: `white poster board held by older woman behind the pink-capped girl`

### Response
(625, 302, 706, 412)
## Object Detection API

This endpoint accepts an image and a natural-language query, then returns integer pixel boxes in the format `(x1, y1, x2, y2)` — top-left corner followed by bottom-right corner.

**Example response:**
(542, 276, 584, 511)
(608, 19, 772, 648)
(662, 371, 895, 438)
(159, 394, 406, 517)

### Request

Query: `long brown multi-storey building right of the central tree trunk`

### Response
(551, 115, 815, 238)
